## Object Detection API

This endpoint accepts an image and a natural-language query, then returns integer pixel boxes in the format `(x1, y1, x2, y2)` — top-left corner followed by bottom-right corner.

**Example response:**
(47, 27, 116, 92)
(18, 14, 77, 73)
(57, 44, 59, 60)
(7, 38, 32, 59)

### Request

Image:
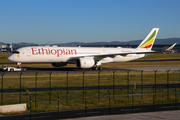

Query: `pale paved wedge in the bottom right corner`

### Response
(65, 110, 180, 120)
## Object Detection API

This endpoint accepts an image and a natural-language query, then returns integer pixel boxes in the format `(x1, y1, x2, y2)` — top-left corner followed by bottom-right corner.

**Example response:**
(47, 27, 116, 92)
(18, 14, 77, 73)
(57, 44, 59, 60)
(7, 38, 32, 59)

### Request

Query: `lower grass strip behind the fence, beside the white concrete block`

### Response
(0, 89, 180, 114)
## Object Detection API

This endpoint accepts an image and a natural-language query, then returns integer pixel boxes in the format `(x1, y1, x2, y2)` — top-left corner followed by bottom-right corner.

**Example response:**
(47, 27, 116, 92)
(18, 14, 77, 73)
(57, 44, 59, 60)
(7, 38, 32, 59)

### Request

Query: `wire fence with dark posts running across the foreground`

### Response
(0, 70, 180, 116)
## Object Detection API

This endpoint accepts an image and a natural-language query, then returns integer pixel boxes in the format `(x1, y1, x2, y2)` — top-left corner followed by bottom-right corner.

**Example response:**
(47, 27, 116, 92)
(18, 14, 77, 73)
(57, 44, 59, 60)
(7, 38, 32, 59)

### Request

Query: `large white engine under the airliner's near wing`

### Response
(76, 58, 95, 68)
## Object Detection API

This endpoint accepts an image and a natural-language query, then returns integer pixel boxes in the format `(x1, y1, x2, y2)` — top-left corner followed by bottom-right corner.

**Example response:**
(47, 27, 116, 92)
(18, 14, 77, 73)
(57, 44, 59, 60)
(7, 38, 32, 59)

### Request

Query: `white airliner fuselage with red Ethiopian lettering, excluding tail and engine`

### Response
(8, 46, 147, 63)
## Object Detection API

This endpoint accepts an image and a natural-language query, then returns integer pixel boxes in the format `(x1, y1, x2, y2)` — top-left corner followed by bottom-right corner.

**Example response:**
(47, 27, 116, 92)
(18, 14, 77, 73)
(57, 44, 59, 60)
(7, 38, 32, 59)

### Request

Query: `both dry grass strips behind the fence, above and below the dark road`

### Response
(0, 71, 180, 114)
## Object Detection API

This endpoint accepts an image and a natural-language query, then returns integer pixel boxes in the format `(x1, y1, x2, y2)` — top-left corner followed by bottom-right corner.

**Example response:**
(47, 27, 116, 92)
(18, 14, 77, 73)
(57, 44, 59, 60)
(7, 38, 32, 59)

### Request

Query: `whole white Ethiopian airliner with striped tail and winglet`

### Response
(7, 28, 175, 70)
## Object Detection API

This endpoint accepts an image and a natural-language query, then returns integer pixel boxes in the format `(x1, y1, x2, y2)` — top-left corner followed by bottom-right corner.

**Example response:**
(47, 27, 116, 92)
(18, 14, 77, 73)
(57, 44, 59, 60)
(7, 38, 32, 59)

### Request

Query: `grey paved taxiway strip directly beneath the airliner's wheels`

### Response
(0, 66, 180, 74)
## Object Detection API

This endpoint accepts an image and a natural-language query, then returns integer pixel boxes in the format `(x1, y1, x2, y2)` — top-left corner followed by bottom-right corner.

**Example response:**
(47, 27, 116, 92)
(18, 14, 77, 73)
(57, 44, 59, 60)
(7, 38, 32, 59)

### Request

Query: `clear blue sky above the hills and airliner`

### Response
(0, 0, 180, 44)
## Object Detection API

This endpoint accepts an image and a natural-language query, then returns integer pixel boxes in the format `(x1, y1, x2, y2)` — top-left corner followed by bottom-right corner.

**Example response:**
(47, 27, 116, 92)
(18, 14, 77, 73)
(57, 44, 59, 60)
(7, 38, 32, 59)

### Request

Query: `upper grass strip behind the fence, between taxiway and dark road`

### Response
(0, 71, 180, 89)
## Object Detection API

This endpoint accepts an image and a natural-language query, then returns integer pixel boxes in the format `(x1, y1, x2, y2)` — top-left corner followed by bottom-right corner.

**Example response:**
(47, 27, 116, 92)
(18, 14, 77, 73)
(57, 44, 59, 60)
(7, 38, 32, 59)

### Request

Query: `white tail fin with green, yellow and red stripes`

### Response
(137, 28, 159, 50)
